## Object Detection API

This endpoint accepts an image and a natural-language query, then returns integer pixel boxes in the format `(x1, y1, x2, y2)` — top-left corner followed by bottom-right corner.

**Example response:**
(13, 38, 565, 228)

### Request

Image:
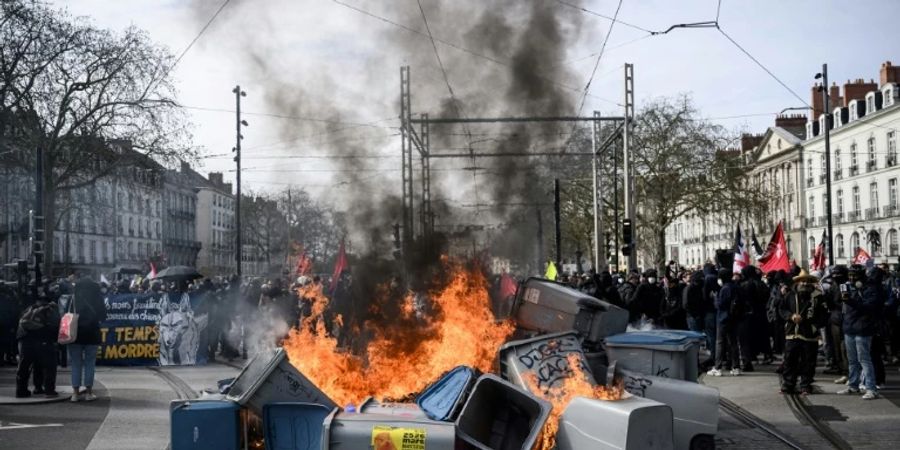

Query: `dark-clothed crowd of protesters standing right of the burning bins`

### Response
(560, 261, 900, 400)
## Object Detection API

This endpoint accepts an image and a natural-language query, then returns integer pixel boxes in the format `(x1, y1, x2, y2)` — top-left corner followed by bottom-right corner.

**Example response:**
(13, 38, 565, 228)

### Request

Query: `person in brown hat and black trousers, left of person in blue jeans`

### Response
(779, 270, 828, 395)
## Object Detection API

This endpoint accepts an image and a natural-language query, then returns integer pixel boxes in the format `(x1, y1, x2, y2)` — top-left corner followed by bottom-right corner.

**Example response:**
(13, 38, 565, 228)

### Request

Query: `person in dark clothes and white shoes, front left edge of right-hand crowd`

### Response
(707, 269, 747, 377)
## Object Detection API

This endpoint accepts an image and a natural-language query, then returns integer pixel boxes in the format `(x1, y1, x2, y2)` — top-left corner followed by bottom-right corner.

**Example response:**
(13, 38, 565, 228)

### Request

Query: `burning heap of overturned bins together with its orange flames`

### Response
(173, 268, 718, 450)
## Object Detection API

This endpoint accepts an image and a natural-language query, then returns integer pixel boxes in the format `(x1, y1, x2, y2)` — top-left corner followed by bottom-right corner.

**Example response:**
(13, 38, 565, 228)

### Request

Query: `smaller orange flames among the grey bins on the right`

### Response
(525, 353, 625, 450)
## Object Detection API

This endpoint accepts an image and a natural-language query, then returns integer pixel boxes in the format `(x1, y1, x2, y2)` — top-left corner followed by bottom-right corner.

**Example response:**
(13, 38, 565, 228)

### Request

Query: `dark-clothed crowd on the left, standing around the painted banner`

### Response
(0, 268, 321, 402)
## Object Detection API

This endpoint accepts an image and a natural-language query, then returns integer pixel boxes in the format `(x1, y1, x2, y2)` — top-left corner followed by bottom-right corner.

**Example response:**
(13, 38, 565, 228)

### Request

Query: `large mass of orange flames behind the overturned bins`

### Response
(283, 263, 513, 405)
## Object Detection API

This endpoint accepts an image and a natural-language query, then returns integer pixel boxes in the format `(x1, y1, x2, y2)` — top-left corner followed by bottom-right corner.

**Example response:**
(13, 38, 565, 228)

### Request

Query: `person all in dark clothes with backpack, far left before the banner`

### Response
(16, 293, 59, 398)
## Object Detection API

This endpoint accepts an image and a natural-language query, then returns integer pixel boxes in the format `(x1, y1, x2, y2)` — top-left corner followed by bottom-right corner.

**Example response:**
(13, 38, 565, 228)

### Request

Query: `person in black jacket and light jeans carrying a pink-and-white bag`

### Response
(68, 276, 106, 402)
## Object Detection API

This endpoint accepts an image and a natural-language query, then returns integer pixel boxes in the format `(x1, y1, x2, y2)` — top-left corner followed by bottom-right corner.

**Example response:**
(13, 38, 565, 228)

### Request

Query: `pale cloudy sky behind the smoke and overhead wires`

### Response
(55, 0, 900, 200)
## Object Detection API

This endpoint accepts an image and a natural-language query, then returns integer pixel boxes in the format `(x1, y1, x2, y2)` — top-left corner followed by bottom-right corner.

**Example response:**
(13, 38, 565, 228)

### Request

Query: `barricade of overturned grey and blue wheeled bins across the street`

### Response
(171, 279, 719, 450)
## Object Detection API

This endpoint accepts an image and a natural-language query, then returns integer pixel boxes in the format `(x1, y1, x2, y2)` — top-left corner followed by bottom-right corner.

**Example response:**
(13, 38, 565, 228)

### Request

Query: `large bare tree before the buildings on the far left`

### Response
(0, 0, 193, 273)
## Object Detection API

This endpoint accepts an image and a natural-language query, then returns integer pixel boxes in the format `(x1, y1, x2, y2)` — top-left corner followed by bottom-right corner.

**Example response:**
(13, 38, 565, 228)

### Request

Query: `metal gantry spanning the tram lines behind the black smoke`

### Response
(400, 64, 634, 269)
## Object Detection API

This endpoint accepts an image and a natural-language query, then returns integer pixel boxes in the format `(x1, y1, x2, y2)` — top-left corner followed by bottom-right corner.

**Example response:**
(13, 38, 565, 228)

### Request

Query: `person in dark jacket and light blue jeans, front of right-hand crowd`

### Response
(838, 264, 884, 400)
